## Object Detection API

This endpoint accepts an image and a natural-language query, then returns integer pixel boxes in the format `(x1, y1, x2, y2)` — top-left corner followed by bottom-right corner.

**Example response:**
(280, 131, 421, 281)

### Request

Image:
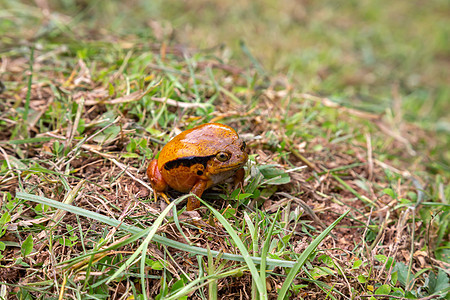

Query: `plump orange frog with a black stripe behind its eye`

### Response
(147, 123, 248, 211)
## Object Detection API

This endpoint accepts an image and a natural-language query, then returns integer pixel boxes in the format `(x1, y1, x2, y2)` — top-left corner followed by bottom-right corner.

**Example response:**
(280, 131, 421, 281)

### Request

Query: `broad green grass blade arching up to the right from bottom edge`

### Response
(277, 210, 350, 300)
